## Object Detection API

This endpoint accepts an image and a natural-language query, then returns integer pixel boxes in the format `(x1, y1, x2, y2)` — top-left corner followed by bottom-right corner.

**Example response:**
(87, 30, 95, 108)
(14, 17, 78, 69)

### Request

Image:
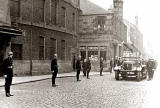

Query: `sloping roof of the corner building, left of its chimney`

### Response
(80, 0, 108, 15)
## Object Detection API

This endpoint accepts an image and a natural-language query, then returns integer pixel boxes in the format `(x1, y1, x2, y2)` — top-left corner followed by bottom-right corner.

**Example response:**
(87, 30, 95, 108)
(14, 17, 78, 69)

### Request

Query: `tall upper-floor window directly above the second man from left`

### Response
(51, 0, 57, 25)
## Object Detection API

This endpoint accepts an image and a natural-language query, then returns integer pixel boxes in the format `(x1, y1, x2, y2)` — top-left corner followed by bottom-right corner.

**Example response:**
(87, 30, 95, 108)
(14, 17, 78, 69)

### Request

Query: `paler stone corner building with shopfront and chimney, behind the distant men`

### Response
(79, 0, 127, 60)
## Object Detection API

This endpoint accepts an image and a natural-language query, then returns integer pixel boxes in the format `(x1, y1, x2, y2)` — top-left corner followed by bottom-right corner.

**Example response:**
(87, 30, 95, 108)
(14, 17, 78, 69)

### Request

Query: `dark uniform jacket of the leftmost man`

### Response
(3, 58, 13, 77)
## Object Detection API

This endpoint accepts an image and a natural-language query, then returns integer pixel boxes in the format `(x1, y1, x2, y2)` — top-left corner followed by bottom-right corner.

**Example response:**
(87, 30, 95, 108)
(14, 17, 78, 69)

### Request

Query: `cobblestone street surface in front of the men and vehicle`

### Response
(0, 74, 156, 108)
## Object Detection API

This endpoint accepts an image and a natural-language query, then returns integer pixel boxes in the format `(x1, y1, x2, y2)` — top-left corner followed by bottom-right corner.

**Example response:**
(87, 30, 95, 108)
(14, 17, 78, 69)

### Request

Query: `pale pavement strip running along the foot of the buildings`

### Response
(0, 72, 110, 87)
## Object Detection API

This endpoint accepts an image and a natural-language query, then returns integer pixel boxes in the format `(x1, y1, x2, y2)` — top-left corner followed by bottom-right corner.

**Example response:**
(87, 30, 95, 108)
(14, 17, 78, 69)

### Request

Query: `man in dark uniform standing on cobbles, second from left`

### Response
(51, 54, 58, 87)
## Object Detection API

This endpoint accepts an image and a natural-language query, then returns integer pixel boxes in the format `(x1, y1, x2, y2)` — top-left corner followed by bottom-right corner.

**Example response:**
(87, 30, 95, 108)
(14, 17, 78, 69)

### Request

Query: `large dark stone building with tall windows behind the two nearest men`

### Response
(6, 0, 80, 75)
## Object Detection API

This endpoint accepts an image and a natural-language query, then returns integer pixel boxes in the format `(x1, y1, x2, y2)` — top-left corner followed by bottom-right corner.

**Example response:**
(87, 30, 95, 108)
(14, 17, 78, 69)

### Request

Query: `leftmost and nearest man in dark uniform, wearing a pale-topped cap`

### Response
(3, 52, 13, 97)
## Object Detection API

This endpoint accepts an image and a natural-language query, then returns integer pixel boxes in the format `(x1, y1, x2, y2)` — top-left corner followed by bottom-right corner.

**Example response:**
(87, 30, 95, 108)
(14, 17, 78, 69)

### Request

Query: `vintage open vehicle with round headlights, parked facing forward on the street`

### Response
(114, 57, 147, 81)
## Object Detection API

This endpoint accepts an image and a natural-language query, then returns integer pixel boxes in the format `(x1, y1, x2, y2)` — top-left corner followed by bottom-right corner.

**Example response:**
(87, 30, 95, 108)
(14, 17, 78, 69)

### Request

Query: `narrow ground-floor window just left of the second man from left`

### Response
(39, 37, 45, 60)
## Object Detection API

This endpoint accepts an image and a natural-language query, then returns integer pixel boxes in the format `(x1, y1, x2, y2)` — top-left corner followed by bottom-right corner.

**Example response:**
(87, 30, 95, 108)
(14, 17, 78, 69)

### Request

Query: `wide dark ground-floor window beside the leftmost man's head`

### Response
(11, 44, 22, 60)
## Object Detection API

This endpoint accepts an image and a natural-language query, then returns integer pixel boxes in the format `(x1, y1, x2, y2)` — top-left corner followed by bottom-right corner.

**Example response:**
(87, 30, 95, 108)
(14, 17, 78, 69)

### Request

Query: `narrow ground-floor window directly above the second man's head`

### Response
(50, 38, 57, 59)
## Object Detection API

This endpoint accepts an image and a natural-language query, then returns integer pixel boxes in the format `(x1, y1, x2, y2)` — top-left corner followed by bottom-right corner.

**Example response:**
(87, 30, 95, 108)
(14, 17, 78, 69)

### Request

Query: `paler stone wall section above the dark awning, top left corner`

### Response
(0, 0, 11, 26)
